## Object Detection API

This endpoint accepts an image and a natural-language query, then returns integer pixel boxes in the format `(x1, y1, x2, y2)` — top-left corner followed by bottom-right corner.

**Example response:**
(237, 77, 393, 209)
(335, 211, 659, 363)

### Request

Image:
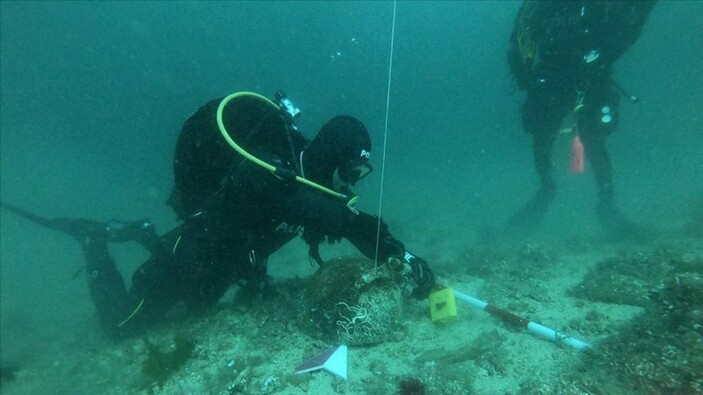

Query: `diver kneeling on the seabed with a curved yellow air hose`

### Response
(3, 92, 434, 338)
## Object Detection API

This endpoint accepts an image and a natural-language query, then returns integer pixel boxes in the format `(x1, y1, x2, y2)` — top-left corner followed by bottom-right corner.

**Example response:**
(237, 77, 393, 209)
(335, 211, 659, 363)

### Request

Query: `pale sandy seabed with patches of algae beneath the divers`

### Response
(1, 234, 703, 395)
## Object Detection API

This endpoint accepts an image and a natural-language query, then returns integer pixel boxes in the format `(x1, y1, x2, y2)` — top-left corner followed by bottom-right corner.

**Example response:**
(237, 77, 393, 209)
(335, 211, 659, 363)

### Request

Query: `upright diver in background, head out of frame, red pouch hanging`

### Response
(508, 0, 655, 237)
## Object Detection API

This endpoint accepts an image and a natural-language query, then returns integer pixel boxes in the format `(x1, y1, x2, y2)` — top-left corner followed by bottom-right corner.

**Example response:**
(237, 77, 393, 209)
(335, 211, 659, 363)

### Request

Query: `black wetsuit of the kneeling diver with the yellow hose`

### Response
(90, 99, 404, 335)
